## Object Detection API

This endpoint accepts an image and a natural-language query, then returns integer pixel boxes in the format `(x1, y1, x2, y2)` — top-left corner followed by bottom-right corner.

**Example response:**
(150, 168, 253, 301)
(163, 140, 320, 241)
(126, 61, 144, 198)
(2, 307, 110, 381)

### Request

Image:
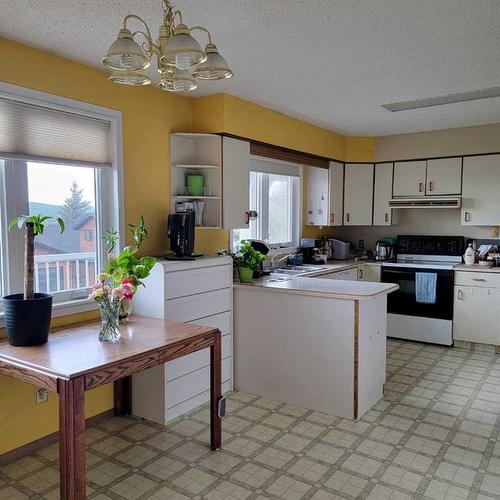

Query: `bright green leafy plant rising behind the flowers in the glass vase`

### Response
(104, 215, 156, 321)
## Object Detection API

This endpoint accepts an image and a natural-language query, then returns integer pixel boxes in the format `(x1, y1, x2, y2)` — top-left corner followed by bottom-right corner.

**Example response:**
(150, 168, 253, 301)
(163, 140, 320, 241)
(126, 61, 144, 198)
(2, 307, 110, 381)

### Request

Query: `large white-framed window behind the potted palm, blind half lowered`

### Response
(0, 84, 122, 312)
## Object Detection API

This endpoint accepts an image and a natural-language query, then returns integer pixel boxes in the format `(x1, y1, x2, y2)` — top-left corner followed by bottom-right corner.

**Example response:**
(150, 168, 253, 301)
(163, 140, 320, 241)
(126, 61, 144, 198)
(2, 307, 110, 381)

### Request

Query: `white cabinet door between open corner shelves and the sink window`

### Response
(222, 137, 250, 229)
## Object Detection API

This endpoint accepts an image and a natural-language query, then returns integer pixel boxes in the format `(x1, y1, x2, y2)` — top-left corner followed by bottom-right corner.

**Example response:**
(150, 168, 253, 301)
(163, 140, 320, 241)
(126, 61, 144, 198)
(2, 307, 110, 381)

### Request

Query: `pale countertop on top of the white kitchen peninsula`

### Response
(234, 274, 399, 300)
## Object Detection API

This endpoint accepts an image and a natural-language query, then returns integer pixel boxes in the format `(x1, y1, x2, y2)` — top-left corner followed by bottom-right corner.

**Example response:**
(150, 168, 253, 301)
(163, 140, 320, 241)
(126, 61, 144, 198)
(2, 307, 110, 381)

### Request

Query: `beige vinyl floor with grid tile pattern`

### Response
(0, 340, 500, 500)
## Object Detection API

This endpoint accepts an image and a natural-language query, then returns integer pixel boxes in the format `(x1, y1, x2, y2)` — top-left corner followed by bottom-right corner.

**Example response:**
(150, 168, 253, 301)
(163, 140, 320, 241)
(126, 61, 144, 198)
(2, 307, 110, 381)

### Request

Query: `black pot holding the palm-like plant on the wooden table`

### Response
(3, 293, 52, 347)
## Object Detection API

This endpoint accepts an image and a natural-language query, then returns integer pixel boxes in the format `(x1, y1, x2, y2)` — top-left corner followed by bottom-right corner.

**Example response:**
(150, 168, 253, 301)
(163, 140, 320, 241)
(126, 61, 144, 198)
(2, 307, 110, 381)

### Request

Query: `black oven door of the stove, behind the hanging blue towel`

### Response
(382, 267, 453, 320)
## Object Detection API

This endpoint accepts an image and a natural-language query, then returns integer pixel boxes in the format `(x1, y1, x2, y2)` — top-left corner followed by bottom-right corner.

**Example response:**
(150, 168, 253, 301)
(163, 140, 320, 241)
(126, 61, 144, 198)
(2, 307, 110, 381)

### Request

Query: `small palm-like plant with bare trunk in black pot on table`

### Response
(3, 215, 64, 346)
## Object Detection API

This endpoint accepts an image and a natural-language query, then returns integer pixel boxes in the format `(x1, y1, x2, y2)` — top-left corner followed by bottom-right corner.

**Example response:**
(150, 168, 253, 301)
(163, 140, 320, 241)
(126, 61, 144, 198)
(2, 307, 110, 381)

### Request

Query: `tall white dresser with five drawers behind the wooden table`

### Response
(132, 257, 233, 425)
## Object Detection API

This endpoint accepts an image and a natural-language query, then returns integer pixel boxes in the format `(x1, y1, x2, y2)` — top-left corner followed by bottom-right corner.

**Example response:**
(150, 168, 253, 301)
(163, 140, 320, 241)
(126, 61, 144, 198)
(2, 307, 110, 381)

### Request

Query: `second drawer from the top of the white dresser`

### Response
(165, 288, 231, 323)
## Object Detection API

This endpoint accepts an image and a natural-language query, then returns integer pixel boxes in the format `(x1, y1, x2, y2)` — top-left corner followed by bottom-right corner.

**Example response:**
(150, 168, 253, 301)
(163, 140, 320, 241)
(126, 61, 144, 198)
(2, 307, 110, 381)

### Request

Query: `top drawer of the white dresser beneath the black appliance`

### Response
(165, 266, 232, 300)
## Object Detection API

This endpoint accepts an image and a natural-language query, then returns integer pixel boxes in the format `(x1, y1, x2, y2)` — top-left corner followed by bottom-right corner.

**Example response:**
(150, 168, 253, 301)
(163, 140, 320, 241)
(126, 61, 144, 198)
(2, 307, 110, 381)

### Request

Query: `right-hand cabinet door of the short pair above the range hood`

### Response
(425, 158, 462, 196)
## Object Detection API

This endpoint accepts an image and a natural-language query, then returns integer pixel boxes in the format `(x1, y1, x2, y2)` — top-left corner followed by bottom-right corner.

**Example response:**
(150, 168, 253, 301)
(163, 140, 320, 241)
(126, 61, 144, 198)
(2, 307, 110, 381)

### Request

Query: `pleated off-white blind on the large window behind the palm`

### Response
(0, 98, 111, 167)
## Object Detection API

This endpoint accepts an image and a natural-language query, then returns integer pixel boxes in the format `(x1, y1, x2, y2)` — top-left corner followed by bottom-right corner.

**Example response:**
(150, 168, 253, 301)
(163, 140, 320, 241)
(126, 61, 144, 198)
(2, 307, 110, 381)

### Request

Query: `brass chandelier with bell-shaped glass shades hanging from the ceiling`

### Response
(101, 0, 233, 92)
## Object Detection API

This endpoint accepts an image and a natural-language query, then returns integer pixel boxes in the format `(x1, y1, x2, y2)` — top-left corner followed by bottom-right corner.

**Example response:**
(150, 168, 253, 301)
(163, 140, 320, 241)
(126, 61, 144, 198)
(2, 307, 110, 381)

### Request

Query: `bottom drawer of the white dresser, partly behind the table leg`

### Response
(166, 358, 232, 408)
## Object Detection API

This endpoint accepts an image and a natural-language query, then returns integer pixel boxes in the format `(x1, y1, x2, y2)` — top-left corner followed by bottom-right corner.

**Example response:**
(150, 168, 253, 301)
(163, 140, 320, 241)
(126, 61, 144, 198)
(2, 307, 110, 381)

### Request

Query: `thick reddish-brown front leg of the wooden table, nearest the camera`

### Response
(58, 377, 86, 500)
